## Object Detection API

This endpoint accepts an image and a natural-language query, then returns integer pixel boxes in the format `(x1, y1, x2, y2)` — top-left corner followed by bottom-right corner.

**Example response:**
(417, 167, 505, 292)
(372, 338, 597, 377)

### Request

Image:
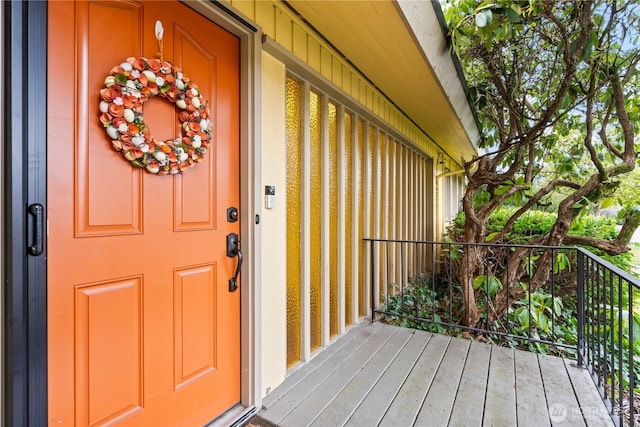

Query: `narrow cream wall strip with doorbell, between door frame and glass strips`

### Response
(257, 52, 287, 397)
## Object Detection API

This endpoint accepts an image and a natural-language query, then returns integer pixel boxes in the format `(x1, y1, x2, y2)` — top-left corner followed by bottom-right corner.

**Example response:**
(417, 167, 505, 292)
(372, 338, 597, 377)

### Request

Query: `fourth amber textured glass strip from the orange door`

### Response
(343, 112, 354, 326)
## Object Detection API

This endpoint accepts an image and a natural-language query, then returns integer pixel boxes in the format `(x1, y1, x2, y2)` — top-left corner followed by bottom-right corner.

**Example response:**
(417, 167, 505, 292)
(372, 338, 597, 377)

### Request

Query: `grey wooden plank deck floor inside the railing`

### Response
(260, 322, 613, 427)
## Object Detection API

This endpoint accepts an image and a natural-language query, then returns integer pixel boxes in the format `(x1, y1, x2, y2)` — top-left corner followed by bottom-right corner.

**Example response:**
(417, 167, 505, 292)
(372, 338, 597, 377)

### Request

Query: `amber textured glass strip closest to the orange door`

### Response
(286, 77, 303, 366)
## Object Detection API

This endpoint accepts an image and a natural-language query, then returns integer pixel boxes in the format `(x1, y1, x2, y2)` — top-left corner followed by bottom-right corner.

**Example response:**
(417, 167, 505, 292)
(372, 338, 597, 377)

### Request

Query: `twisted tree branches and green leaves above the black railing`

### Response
(441, 0, 640, 268)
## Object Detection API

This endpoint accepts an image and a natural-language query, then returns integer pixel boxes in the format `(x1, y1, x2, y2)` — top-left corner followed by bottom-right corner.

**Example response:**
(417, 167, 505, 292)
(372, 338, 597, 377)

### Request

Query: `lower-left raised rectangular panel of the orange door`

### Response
(74, 277, 143, 425)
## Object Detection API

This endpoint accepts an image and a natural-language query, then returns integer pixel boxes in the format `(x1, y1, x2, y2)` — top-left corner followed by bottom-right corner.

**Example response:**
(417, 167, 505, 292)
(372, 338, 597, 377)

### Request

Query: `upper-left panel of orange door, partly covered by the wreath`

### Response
(77, 2, 144, 236)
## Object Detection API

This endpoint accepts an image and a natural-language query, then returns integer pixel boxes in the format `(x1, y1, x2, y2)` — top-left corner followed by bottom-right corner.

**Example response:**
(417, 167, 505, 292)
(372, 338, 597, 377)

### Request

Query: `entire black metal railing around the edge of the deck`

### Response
(363, 239, 640, 426)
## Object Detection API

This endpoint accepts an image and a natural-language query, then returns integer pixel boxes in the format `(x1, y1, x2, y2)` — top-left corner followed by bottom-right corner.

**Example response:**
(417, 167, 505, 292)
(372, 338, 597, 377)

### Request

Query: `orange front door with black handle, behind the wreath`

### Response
(45, 1, 240, 427)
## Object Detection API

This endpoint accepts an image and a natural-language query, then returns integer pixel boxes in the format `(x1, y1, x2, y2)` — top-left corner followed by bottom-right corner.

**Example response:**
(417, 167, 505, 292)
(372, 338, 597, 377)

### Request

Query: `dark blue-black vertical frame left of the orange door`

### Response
(2, 2, 47, 426)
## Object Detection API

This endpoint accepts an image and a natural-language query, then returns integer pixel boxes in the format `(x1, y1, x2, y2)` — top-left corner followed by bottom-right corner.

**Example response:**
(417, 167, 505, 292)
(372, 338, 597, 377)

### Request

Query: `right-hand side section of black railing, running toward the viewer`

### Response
(576, 249, 640, 426)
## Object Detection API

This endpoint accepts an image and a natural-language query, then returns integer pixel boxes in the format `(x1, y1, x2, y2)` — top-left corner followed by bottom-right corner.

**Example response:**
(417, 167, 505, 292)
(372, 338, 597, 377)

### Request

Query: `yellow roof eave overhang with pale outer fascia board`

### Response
(288, 0, 480, 162)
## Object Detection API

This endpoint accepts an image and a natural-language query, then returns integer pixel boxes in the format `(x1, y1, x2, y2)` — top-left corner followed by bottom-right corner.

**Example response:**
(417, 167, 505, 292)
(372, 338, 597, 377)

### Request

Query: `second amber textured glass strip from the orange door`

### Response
(309, 91, 322, 350)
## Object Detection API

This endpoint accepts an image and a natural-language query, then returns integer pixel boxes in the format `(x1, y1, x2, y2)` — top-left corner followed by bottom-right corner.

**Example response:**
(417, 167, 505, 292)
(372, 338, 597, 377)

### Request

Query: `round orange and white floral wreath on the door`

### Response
(100, 57, 212, 175)
